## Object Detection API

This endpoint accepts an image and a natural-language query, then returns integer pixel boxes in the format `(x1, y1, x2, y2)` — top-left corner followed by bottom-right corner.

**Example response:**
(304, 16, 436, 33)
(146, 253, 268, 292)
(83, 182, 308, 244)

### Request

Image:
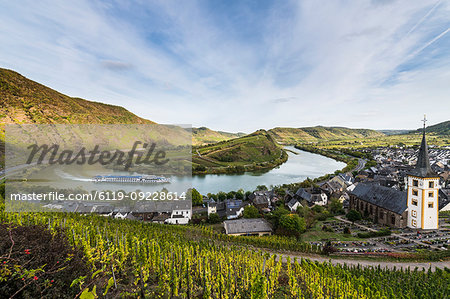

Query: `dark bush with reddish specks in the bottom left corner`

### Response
(0, 224, 91, 298)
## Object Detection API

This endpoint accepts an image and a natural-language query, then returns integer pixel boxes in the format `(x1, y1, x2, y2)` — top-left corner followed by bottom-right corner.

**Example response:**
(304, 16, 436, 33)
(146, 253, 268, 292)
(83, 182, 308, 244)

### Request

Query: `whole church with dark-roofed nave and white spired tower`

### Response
(350, 119, 439, 229)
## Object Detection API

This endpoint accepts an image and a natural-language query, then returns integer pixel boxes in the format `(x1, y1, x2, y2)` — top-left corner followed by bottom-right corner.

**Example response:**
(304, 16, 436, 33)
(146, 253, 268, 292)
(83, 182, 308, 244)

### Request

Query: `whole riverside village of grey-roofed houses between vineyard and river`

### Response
(43, 130, 450, 254)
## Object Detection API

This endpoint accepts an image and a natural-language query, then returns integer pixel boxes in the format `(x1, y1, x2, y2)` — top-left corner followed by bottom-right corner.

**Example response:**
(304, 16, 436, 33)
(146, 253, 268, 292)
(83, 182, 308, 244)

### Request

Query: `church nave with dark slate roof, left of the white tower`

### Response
(350, 183, 408, 228)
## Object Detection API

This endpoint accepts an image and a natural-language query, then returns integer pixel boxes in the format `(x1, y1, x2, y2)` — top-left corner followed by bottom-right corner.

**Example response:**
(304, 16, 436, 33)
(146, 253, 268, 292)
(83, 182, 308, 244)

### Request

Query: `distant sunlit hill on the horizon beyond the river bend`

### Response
(269, 126, 384, 144)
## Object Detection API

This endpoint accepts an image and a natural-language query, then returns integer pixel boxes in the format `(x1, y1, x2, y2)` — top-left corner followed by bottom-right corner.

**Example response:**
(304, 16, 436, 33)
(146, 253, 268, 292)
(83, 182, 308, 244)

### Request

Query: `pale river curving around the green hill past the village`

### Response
(22, 146, 345, 194)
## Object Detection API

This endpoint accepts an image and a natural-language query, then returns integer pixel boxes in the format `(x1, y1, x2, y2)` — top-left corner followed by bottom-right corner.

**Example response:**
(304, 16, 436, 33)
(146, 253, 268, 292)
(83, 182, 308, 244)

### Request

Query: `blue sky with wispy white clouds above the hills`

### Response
(0, 0, 450, 133)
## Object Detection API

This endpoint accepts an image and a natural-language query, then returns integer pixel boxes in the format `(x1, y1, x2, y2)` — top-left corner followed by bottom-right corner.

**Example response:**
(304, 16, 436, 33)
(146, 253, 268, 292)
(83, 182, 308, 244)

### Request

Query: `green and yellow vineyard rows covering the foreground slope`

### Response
(0, 212, 450, 298)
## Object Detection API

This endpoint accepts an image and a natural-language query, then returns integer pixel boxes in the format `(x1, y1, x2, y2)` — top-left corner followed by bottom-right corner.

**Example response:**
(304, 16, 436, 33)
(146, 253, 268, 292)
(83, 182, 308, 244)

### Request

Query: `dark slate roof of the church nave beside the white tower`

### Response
(351, 183, 407, 214)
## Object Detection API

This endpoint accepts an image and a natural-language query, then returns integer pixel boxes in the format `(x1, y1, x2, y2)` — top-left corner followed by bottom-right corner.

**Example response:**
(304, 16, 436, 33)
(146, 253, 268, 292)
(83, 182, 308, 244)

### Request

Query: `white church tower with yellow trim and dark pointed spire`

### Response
(407, 117, 439, 229)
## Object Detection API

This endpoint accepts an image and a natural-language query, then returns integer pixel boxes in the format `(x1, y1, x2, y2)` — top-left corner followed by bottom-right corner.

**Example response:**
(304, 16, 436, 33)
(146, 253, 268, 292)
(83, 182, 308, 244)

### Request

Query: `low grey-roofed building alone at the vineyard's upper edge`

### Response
(223, 218, 272, 236)
